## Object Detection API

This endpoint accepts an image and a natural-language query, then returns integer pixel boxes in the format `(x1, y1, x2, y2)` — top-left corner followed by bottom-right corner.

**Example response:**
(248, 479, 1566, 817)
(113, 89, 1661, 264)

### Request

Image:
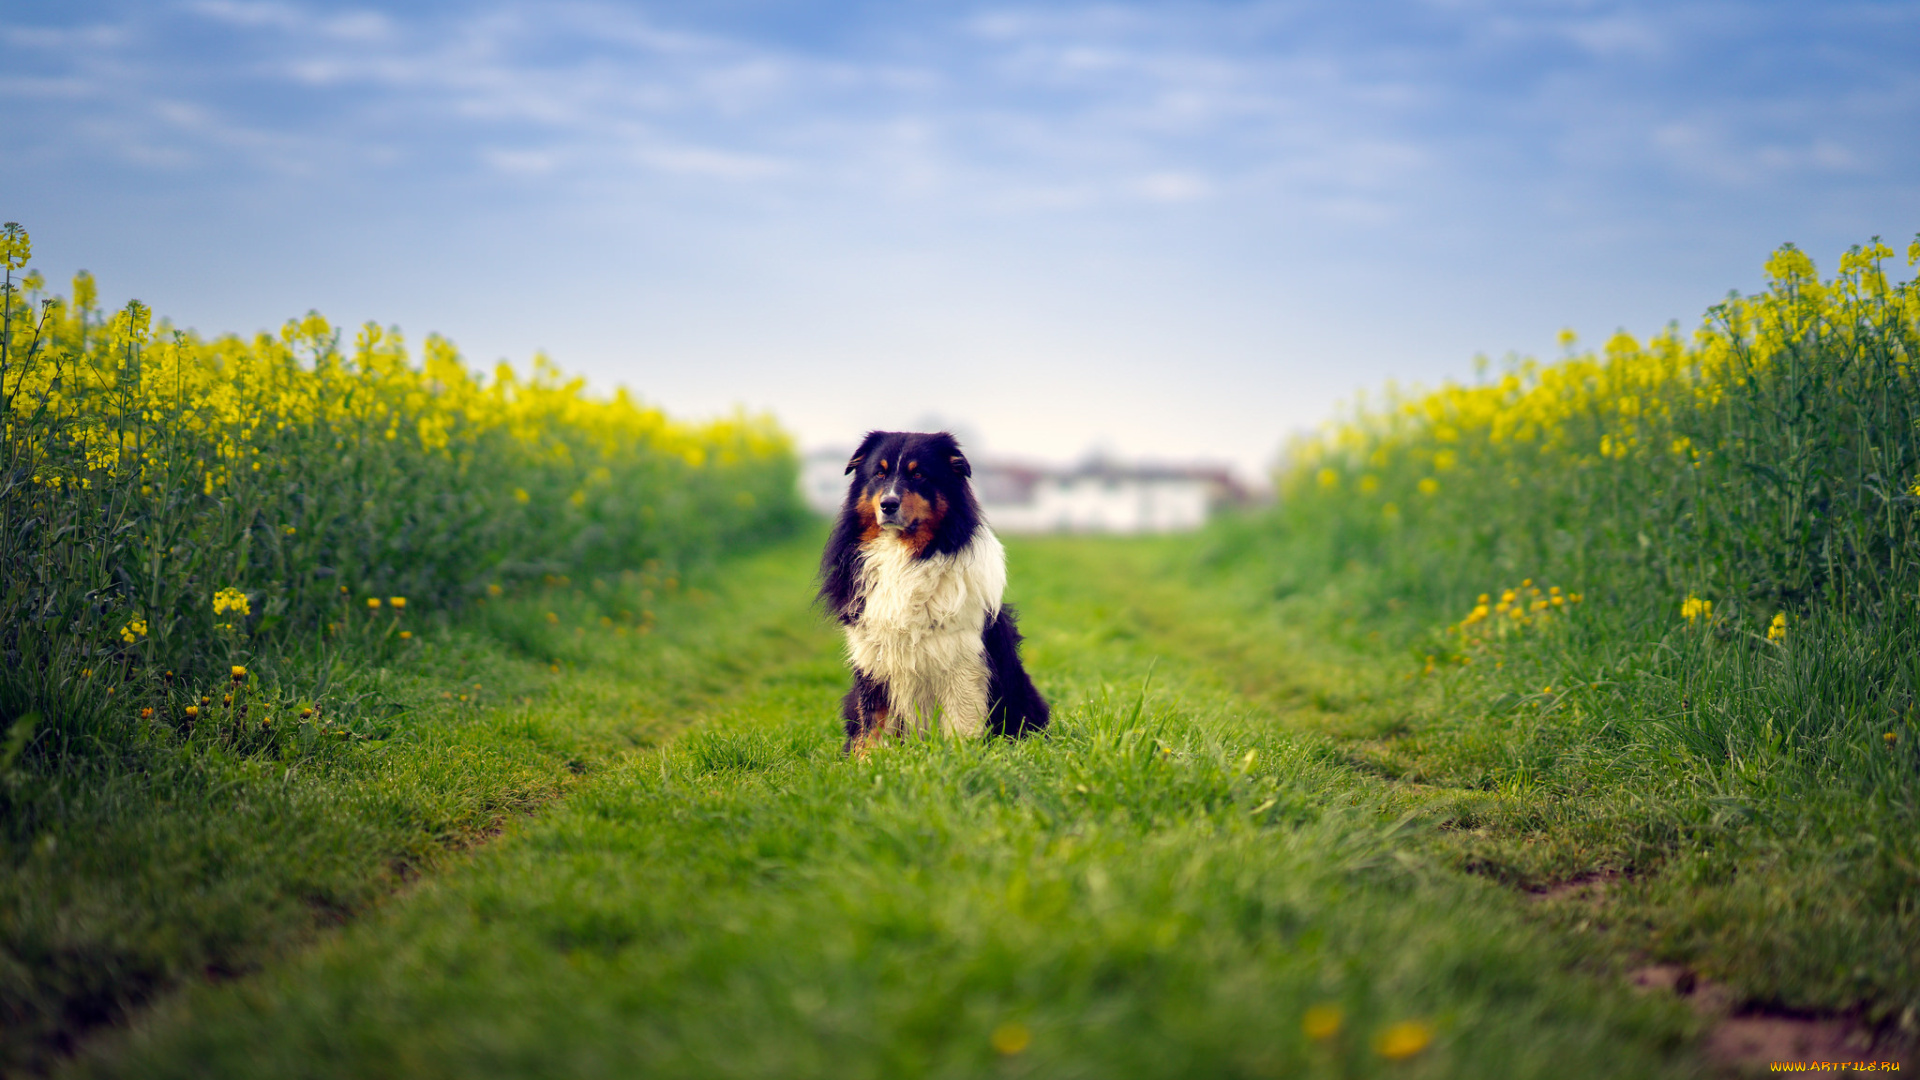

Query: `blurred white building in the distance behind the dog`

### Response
(801, 450, 1246, 532)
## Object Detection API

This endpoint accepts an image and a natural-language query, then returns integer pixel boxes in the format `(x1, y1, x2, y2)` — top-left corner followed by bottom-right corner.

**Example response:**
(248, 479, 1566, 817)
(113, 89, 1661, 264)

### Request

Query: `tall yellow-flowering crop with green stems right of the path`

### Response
(1219, 240, 1920, 1013)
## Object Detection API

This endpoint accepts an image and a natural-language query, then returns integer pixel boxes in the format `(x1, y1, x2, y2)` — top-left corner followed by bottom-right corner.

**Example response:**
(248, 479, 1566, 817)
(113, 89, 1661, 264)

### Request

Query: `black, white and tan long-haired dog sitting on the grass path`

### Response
(820, 430, 1048, 753)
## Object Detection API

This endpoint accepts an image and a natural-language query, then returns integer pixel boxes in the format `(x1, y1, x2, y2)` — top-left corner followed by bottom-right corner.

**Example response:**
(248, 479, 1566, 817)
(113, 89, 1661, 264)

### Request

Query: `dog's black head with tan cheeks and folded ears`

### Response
(847, 430, 975, 550)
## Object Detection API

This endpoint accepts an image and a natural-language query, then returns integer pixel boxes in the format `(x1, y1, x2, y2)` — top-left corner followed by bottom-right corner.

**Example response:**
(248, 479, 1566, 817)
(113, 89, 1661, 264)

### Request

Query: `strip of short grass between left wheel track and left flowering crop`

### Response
(0, 544, 826, 1072)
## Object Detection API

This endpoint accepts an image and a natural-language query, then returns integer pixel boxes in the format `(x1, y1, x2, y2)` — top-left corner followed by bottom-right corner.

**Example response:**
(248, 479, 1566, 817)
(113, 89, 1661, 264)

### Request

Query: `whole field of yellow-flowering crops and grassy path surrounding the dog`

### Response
(0, 227, 1920, 1080)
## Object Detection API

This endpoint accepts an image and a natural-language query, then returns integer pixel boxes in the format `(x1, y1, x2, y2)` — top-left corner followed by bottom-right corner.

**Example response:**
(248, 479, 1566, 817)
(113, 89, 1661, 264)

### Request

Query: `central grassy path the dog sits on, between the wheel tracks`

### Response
(60, 540, 1695, 1078)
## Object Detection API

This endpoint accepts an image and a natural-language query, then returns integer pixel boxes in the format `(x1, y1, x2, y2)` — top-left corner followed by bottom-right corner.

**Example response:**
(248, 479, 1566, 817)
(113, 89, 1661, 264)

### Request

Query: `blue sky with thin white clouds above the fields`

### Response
(0, 0, 1920, 473)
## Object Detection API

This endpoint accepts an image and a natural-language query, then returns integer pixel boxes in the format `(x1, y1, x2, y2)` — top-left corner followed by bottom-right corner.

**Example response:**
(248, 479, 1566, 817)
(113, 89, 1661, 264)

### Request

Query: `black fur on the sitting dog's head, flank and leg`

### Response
(820, 430, 1048, 749)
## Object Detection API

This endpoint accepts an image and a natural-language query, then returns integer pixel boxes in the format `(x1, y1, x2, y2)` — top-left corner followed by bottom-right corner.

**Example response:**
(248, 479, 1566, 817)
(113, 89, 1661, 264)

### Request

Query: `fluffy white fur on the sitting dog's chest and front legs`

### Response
(847, 525, 1006, 738)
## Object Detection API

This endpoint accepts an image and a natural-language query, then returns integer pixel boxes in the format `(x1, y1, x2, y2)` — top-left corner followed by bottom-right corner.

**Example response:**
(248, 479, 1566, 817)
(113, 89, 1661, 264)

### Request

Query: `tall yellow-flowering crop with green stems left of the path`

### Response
(0, 223, 801, 769)
